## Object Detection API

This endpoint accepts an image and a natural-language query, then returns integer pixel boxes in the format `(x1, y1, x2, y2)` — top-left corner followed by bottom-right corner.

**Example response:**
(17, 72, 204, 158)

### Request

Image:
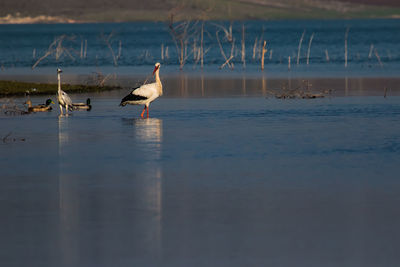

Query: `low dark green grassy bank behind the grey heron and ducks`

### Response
(0, 81, 121, 97)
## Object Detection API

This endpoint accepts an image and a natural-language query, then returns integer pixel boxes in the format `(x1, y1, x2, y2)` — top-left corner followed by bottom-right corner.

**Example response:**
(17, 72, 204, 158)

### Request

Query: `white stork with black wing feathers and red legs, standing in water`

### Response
(120, 63, 163, 118)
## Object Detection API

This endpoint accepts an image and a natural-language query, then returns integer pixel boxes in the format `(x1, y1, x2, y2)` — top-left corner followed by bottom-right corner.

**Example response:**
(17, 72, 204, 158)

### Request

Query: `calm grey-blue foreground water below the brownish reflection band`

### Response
(0, 92, 400, 266)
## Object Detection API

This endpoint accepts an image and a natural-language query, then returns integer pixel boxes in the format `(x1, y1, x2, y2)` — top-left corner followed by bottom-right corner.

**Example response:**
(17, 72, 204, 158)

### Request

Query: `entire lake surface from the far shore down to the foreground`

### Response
(0, 20, 400, 267)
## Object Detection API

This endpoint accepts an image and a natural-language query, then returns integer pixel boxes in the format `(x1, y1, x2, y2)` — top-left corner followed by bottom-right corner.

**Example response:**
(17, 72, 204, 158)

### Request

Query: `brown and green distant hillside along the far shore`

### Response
(0, 0, 400, 23)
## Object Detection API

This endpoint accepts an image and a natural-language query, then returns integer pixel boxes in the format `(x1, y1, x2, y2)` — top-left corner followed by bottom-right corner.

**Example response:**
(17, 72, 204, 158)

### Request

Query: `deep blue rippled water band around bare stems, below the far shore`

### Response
(0, 19, 400, 76)
